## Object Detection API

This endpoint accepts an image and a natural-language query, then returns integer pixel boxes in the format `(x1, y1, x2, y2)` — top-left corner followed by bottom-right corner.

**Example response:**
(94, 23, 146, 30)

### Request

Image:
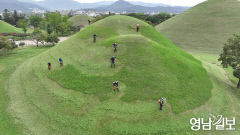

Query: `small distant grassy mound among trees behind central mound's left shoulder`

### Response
(69, 15, 92, 26)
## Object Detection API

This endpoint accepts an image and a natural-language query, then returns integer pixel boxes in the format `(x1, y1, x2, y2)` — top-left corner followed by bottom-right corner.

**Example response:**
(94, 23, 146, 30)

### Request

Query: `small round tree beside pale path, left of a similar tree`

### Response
(31, 29, 46, 47)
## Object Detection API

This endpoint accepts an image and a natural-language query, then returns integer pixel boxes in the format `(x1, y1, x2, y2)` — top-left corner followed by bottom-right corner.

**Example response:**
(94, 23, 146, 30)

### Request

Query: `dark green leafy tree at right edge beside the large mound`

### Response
(218, 35, 240, 88)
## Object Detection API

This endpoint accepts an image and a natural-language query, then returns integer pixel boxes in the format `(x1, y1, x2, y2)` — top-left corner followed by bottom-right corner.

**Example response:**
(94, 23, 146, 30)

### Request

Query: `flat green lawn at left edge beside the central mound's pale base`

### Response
(0, 48, 49, 135)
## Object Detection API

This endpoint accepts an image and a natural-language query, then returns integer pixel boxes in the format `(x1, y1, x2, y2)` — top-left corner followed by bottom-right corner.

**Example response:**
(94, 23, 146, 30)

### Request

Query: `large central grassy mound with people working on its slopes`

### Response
(8, 16, 212, 134)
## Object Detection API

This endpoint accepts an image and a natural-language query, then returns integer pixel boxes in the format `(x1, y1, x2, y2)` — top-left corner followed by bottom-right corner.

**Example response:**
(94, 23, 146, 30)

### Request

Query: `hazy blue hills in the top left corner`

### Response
(0, 0, 45, 12)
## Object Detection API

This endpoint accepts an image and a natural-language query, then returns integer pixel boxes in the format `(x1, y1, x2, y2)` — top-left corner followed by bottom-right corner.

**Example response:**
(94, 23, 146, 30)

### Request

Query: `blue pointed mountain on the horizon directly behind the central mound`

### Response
(95, 0, 188, 14)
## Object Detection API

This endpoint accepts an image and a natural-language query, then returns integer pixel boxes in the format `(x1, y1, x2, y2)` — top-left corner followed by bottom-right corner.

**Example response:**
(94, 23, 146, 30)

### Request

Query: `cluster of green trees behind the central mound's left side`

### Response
(0, 9, 78, 46)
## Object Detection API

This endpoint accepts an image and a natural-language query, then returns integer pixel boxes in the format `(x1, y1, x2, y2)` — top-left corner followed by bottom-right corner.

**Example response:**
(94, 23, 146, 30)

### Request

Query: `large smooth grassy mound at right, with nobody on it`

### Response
(156, 0, 240, 53)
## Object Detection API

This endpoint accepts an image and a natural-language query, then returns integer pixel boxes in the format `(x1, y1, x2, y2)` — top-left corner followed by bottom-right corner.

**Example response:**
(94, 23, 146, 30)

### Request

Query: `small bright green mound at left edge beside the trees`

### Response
(0, 20, 22, 33)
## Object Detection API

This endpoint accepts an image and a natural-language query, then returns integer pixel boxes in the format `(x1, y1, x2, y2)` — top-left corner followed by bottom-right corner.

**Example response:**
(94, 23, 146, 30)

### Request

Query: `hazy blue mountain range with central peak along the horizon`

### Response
(18, 0, 188, 13)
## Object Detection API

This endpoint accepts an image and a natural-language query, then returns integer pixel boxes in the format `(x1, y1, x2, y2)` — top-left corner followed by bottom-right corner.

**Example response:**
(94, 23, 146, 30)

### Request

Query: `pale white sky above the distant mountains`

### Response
(75, 0, 206, 6)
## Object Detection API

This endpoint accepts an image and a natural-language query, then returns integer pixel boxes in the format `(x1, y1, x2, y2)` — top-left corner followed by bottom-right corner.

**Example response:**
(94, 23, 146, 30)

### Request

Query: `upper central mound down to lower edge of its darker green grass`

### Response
(45, 16, 212, 113)
